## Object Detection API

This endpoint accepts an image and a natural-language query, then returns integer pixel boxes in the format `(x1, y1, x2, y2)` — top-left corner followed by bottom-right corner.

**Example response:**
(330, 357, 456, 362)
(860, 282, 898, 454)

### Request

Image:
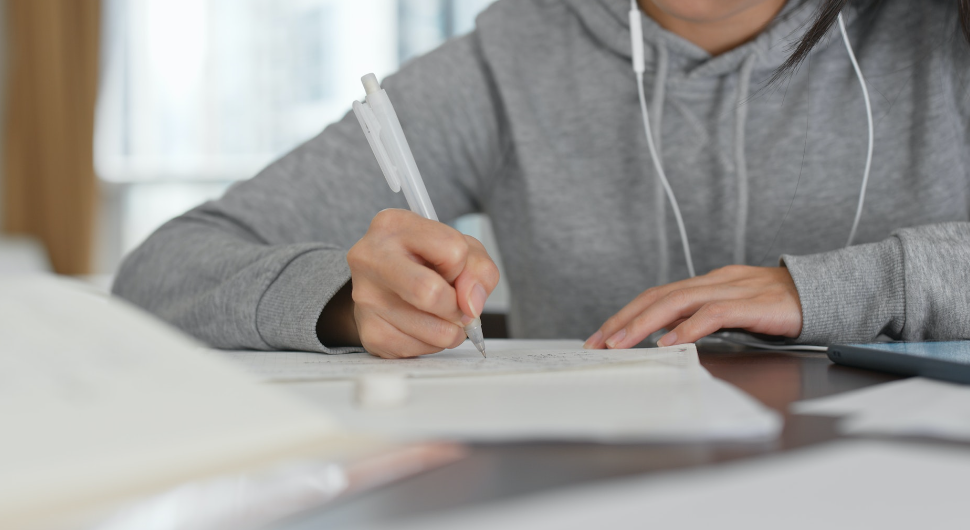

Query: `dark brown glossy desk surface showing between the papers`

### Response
(283, 340, 899, 530)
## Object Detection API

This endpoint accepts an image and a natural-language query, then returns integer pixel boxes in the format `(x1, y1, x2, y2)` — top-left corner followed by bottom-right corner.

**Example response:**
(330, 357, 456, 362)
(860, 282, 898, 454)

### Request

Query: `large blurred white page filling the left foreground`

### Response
(0, 276, 341, 528)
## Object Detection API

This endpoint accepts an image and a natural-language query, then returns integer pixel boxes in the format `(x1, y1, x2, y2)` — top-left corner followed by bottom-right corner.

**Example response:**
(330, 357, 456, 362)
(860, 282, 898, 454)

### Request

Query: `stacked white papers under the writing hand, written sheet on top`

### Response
(226, 340, 782, 442)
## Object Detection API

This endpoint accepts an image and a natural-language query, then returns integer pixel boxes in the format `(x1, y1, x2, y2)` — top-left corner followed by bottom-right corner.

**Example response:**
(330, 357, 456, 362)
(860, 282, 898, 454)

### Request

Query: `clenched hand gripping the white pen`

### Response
(347, 210, 499, 358)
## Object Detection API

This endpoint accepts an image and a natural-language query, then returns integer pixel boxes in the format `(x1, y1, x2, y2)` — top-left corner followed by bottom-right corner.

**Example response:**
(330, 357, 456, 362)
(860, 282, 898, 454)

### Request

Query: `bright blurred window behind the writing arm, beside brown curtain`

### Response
(95, 0, 492, 258)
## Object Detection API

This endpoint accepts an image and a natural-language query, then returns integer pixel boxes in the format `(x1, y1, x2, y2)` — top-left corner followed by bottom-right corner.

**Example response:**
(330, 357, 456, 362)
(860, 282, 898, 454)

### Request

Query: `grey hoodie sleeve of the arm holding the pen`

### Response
(113, 33, 501, 353)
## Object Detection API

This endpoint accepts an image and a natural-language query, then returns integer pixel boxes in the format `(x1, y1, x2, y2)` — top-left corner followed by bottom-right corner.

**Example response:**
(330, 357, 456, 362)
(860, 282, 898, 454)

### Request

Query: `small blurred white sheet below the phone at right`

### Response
(791, 377, 970, 441)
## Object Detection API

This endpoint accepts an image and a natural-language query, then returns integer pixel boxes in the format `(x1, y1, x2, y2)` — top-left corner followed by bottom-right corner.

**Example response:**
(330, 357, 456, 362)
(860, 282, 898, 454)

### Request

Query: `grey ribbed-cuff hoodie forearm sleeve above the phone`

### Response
(782, 223, 970, 344)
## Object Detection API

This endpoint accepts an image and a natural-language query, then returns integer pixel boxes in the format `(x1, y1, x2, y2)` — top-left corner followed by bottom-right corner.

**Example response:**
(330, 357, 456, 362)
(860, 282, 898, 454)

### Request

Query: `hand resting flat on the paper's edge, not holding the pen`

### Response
(585, 265, 802, 349)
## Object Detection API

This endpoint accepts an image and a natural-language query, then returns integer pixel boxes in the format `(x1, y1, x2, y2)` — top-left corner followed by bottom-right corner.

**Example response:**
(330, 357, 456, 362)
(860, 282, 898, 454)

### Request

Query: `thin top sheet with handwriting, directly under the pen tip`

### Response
(219, 340, 699, 381)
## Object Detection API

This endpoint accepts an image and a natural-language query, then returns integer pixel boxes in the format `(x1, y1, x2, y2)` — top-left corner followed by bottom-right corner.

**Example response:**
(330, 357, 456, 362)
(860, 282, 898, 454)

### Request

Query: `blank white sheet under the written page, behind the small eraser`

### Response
(285, 350, 782, 442)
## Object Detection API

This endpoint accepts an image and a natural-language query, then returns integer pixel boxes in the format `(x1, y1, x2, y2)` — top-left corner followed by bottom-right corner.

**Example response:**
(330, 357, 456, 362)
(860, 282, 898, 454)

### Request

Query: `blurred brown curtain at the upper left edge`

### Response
(2, 0, 101, 274)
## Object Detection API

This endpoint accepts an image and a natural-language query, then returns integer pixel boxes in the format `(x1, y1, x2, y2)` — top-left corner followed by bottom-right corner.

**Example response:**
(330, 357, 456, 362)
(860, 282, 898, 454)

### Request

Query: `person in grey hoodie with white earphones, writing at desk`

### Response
(114, 0, 970, 357)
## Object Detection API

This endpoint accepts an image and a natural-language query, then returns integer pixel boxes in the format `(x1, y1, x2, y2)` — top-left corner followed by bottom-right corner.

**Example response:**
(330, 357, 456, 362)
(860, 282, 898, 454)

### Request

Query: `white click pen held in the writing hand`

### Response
(354, 74, 485, 357)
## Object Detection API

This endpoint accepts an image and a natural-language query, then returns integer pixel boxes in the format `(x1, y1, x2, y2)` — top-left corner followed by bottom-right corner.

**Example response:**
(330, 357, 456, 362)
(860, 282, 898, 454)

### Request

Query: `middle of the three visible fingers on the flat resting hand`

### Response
(606, 285, 748, 349)
